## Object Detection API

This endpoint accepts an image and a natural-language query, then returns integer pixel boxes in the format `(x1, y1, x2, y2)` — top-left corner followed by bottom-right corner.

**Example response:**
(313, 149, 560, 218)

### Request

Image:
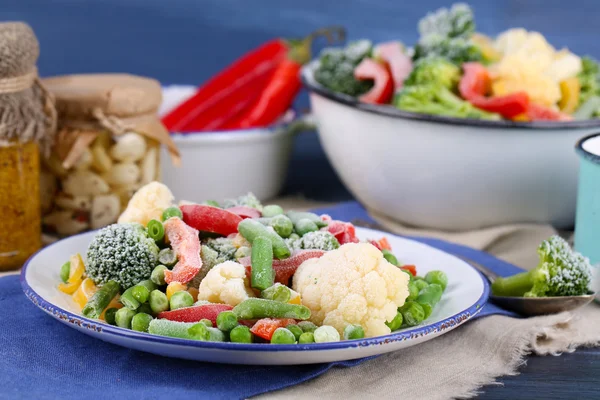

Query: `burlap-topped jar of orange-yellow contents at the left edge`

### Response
(0, 22, 56, 271)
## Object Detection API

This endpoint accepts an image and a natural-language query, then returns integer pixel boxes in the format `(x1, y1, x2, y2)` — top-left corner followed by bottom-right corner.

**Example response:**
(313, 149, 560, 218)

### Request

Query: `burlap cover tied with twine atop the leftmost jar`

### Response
(0, 22, 56, 153)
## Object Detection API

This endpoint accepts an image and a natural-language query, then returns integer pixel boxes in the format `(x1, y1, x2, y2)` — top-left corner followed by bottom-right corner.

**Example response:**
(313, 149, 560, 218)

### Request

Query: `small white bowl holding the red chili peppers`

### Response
(161, 86, 294, 201)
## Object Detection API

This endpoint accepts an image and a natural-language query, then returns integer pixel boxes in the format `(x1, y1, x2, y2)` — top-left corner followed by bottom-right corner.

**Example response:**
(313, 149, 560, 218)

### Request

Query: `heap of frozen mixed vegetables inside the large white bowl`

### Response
(314, 3, 600, 122)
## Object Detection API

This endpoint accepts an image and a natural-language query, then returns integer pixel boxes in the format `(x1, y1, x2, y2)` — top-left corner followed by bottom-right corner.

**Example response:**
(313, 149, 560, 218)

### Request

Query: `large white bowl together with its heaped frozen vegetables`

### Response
(302, 5, 600, 230)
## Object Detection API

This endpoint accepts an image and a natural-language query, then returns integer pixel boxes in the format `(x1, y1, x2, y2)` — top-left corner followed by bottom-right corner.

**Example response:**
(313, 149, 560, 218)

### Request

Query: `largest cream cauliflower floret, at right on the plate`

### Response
(293, 243, 409, 337)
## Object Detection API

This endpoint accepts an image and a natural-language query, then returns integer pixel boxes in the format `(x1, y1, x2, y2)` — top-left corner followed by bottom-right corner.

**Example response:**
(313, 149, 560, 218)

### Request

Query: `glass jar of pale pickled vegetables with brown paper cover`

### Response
(41, 74, 179, 237)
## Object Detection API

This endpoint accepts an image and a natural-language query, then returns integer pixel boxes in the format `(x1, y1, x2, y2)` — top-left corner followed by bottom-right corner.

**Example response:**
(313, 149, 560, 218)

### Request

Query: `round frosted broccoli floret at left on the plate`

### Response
(86, 224, 159, 289)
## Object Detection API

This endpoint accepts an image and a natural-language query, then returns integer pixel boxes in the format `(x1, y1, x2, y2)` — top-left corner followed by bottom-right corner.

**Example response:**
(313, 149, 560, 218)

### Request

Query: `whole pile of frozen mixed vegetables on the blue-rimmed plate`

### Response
(58, 182, 448, 344)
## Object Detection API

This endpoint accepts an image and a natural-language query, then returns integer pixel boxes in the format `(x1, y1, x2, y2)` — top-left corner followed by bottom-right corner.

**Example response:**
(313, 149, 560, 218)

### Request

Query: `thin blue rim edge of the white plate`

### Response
(20, 232, 490, 352)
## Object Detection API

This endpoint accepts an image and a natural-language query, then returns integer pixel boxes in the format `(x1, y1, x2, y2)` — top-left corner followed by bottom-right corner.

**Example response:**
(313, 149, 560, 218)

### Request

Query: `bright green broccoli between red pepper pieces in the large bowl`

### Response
(394, 84, 500, 120)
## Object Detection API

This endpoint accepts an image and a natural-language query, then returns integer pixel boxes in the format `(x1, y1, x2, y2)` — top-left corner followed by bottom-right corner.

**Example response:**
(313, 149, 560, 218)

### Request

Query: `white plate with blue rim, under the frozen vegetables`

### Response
(21, 228, 489, 365)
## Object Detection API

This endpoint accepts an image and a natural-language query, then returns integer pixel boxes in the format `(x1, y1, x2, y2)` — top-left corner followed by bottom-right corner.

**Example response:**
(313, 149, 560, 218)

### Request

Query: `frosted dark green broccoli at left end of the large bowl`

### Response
(315, 40, 373, 96)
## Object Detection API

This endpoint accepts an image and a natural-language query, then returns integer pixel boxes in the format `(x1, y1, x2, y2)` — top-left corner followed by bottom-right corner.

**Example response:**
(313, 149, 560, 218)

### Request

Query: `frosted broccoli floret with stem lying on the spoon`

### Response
(492, 236, 591, 297)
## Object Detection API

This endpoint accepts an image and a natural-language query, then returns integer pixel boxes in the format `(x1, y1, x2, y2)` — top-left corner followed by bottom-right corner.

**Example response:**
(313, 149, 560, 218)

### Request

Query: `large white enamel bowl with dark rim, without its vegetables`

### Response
(302, 62, 600, 230)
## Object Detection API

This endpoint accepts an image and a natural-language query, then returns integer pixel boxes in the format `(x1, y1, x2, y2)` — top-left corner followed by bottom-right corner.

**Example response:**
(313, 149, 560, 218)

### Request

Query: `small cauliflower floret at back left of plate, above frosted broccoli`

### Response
(119, 182, 174, 226)
